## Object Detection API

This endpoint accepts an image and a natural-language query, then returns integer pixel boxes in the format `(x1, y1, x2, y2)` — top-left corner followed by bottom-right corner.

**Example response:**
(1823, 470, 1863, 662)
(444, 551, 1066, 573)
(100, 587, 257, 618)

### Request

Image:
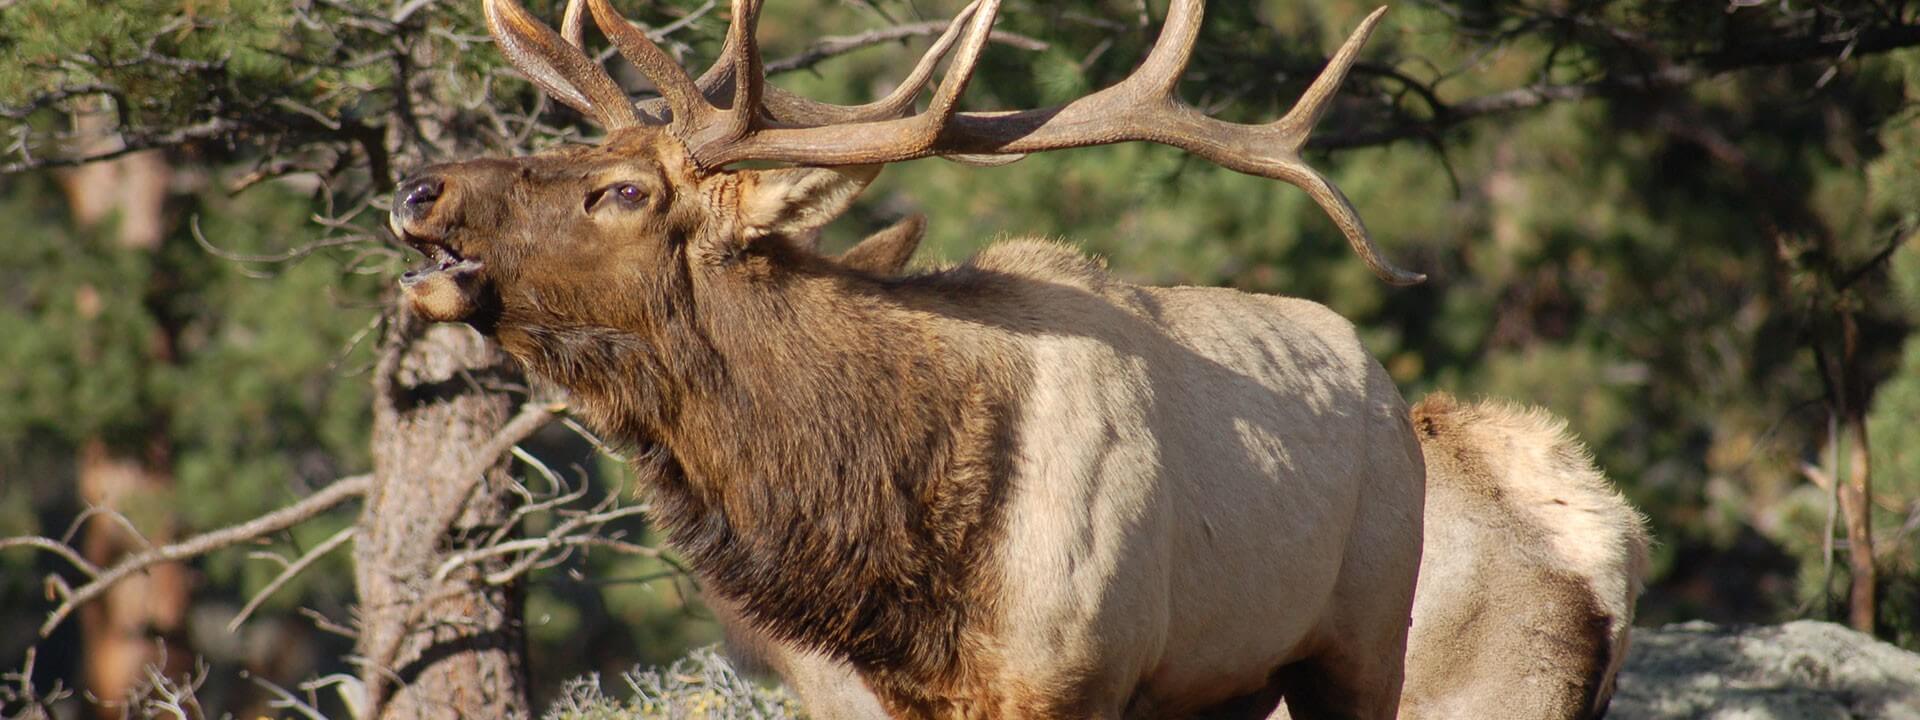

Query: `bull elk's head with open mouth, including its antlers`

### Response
(392, 0, 1423, 341)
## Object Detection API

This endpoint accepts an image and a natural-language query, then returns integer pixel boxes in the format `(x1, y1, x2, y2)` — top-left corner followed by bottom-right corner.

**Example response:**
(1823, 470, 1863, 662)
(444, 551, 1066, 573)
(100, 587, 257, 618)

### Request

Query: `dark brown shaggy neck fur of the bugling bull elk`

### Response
(499, 242, 1025, 703)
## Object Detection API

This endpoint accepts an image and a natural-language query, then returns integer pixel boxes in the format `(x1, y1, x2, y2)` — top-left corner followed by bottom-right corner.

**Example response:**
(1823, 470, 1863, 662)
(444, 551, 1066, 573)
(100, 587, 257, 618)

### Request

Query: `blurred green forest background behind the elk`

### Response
(0, 0, 1920, 714)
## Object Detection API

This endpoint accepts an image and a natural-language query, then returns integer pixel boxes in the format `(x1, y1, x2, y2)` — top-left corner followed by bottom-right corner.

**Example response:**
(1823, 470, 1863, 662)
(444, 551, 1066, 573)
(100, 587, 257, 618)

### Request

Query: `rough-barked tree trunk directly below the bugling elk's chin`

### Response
(353, 317, 532, 718)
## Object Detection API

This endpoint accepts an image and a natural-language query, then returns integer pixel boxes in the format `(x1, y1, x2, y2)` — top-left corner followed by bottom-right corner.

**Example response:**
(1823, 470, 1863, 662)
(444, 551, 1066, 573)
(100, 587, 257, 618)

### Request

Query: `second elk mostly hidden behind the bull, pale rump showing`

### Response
(714, 235, 1647, 720)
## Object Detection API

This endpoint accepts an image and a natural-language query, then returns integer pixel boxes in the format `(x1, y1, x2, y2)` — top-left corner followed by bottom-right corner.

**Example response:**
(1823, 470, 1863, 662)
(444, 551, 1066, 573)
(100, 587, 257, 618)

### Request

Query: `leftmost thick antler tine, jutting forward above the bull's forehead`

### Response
(482, 0, 639, 131)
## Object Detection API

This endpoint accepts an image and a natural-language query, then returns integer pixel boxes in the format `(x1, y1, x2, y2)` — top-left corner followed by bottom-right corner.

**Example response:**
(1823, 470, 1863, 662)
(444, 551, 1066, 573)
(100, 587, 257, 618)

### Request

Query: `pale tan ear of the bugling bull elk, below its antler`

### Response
(739, 165, 881, 240)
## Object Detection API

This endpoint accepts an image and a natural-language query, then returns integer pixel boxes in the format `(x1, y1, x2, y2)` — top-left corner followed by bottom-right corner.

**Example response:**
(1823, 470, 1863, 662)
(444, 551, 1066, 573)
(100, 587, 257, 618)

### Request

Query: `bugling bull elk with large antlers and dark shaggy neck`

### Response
(390, 0, 1425, 718)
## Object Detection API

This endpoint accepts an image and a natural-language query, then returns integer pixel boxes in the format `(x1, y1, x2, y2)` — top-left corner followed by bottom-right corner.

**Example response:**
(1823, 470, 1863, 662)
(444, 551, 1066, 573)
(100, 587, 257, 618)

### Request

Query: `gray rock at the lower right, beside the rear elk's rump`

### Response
(1607, 620, 1920, 720)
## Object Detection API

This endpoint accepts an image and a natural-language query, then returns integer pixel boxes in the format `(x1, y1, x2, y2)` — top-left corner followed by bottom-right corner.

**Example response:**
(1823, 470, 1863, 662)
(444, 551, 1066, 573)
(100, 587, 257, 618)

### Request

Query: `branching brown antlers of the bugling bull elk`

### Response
(486, 0, 1427, 284)
